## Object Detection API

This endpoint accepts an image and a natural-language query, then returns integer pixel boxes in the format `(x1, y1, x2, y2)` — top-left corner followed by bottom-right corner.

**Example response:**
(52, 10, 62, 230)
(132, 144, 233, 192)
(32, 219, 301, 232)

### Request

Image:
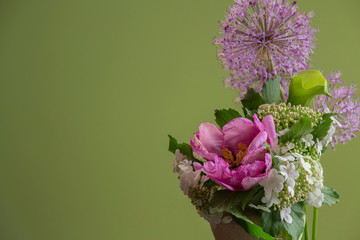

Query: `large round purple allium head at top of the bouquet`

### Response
(215, 0, 317, 100)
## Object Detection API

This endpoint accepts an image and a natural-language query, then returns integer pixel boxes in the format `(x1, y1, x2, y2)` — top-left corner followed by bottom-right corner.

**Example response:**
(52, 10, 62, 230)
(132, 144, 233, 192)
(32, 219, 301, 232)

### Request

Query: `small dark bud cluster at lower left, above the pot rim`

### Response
(188, 185, 217, 215)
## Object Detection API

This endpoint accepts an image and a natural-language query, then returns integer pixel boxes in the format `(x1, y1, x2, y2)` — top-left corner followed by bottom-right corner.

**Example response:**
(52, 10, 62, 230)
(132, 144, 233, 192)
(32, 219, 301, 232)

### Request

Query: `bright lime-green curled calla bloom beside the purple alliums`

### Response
(287, 70, 331, 106)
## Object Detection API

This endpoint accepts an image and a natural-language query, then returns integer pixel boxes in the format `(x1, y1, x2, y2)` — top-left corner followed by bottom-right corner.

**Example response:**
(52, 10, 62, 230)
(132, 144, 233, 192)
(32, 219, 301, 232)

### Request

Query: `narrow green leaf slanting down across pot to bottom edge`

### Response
(229, 207, 276, 240)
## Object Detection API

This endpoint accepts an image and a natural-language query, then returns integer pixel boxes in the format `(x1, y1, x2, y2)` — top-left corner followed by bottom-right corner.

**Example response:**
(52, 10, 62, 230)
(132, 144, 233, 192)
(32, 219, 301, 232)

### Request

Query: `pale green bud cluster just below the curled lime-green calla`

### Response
(257, 103, 322, 132)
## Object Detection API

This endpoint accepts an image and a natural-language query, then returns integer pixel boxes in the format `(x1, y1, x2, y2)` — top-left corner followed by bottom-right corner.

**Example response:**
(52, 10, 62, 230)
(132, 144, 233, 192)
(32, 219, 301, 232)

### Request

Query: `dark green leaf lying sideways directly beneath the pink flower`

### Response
(210, 188, 258, 212)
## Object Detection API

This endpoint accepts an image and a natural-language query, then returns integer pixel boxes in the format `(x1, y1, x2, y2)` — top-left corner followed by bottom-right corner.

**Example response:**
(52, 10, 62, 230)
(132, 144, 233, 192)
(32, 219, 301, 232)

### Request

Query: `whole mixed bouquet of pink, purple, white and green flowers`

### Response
(169, 0, 360, 240)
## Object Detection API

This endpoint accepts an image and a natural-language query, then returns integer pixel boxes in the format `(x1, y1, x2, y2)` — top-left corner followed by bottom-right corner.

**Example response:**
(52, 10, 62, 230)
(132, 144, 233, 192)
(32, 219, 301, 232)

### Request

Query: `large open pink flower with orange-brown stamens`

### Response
(190, 114, 277, 191)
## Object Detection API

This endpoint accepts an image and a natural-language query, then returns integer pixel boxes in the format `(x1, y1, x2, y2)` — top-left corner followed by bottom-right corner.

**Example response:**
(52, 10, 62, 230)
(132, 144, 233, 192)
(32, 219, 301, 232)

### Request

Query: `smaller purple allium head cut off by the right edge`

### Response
(315, 71, 360, 149)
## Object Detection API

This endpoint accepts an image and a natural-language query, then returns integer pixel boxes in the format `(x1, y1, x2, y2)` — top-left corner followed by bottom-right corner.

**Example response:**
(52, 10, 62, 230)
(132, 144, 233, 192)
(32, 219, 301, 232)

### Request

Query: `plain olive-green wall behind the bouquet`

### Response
(0, 0, 360, 240)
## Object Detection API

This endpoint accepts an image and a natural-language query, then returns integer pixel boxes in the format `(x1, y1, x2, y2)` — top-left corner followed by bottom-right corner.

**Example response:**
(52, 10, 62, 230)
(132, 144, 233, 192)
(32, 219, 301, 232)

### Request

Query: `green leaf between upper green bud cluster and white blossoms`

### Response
(280, 116, 312, 143)
